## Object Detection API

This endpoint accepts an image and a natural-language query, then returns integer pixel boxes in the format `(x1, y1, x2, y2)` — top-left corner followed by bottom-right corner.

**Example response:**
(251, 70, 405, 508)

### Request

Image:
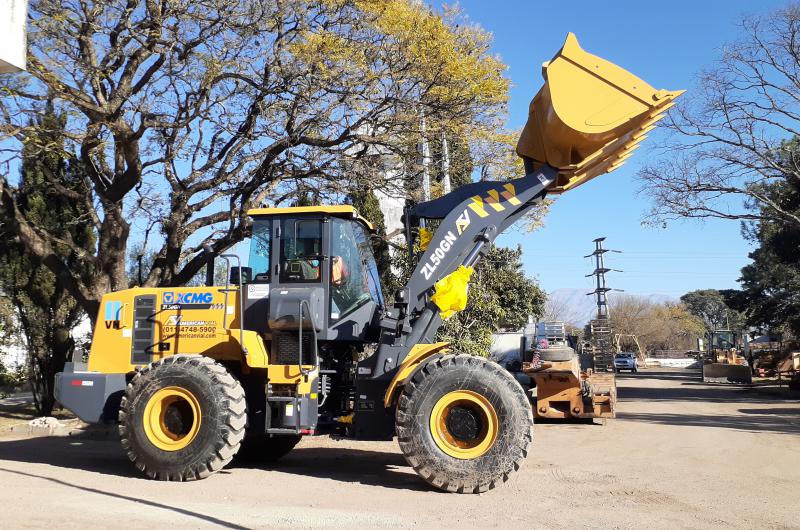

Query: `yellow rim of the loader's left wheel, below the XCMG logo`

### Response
(144, 386, 201, 451)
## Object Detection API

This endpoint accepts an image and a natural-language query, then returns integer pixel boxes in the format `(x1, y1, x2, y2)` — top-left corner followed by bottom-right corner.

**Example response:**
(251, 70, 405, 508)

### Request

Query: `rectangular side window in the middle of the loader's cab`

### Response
(280, 219, 322, 283)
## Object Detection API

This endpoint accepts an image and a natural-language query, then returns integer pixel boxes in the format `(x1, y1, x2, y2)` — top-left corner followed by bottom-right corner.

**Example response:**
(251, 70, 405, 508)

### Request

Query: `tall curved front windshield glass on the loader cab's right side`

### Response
(330, 219, 382, 320)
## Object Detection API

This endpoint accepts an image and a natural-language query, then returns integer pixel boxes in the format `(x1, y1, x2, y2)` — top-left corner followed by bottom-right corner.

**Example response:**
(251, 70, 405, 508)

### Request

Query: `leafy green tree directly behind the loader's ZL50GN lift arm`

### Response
(437, 247, 547, 356)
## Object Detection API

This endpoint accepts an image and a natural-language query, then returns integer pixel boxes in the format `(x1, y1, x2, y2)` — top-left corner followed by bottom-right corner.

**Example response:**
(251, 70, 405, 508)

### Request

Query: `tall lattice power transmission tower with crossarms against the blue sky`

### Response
(584, 237, 622, 372)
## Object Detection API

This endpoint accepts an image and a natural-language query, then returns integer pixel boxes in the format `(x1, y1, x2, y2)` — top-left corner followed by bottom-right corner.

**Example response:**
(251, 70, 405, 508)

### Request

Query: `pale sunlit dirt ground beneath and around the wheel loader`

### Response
(0, 370, 800, 528)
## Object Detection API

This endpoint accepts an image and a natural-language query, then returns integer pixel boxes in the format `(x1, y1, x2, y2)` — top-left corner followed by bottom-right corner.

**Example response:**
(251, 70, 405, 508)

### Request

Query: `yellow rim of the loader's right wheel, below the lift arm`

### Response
(430, 390, 500, 460)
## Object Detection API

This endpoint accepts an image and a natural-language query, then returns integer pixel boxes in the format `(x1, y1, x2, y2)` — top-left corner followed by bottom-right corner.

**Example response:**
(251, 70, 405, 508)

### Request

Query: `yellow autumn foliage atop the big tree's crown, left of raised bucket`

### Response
(289, 0, 509, 110)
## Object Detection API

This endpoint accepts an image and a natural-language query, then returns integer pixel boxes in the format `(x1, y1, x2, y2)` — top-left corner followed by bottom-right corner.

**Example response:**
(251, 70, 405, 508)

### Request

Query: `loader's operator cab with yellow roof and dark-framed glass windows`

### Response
(241, 206, 384, 344)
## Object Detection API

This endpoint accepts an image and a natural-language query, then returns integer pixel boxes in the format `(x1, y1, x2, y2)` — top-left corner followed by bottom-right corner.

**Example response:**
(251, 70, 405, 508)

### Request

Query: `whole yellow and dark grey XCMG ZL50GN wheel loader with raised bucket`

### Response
(56, 34, 680, 493)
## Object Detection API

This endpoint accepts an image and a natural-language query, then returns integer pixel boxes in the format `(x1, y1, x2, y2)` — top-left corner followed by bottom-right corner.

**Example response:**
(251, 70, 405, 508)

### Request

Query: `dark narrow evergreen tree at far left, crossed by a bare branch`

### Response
(0, 102, 95, 410)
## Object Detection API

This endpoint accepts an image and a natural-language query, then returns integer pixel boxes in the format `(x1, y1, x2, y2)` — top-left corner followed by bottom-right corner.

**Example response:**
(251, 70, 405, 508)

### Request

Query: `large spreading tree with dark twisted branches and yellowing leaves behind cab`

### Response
(0, 0, 508, 318)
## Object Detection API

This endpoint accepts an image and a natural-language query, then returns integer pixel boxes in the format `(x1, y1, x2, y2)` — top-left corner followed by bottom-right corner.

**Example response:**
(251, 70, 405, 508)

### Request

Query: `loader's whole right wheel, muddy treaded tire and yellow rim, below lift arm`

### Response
(396, 355, 533, 493)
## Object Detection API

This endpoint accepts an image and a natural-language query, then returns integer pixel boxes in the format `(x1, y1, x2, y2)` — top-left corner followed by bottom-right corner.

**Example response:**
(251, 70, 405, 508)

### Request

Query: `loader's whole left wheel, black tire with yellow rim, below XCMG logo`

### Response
(119, 355, 247, 481)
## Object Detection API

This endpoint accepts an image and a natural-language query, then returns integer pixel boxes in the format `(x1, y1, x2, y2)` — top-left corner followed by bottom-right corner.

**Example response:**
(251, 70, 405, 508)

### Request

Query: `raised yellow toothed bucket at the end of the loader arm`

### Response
(517, 33, 684, 193)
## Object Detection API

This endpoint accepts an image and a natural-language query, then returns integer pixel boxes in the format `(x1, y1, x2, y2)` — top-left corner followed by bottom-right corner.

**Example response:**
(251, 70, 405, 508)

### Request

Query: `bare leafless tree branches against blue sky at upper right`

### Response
(639, 3, 800, 226)
